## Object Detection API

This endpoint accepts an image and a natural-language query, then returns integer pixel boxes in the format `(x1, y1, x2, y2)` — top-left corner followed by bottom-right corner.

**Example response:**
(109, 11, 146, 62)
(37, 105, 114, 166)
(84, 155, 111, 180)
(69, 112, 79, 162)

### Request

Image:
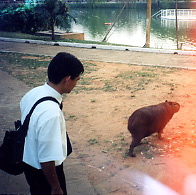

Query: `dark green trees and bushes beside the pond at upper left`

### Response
(0, 0, 75, 40)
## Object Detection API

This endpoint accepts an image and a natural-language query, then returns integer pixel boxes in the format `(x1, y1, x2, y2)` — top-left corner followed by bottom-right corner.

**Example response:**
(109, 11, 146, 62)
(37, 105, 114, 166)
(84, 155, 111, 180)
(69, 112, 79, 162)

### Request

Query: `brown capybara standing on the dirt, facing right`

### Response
(128, 101, 180, 157)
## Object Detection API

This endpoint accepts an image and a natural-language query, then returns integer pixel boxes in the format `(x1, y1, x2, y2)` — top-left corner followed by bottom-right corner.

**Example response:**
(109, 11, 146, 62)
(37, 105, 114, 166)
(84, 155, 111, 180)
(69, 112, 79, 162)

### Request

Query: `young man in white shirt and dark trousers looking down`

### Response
(20, 52, 84, 194)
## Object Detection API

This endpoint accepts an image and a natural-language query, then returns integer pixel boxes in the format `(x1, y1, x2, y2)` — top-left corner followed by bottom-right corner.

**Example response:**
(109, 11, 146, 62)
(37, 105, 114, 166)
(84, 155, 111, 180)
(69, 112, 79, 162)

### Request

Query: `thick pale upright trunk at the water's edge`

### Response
(144, 0, 152, 47)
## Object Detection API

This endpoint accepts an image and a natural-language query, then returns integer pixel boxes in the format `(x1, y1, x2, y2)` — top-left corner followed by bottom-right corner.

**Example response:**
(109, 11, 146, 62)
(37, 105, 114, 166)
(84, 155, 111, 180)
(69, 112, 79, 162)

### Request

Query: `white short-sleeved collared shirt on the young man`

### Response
(20, 83, 67, 169)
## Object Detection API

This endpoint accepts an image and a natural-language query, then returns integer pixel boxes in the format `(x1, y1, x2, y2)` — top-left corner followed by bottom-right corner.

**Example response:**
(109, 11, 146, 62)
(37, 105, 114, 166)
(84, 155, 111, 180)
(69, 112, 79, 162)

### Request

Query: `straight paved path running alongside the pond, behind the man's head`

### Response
(0, 38, 196, 70)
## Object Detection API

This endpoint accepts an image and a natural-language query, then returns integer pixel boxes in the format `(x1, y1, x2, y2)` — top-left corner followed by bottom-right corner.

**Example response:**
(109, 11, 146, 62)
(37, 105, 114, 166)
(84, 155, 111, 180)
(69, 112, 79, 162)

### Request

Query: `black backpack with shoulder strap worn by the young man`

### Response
(0, 97, 72, 175)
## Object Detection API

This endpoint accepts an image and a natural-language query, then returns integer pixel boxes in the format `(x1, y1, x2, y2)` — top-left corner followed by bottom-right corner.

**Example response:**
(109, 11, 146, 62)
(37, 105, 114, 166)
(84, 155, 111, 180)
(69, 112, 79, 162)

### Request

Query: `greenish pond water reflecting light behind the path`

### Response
(67, 8, 196, 50)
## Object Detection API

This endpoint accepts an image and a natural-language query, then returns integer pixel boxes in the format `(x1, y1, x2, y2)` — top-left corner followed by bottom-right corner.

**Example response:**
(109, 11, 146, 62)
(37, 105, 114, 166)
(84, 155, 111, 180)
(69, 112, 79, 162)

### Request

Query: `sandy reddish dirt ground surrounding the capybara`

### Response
(0, 40, 196, 195)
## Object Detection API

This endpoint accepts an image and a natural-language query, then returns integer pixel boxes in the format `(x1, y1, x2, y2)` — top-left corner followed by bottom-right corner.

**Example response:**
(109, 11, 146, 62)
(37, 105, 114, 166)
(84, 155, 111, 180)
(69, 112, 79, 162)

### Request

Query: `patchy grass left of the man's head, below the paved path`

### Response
(0, 52, 51, 86)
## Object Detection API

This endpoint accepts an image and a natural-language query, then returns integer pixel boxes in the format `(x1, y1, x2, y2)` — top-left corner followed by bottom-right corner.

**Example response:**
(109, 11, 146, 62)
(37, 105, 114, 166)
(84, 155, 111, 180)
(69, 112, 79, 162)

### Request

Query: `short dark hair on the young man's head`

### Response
(48, 52, 84, 84)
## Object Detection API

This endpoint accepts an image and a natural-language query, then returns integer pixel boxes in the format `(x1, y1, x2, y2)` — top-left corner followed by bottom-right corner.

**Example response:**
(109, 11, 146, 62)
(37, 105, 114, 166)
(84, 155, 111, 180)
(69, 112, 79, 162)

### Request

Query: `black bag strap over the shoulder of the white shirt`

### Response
(21, 96, 60, 137)
